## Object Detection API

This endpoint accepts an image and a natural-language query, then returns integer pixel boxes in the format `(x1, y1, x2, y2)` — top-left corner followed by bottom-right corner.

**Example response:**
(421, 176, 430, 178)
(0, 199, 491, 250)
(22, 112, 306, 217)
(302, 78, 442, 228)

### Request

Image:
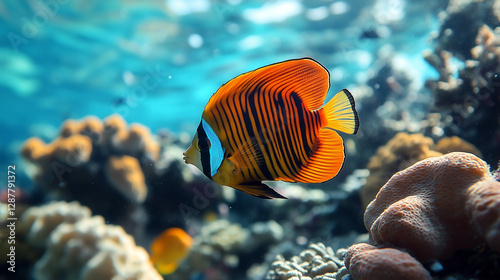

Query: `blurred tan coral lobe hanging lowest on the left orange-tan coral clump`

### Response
(105, 156, 148, 203)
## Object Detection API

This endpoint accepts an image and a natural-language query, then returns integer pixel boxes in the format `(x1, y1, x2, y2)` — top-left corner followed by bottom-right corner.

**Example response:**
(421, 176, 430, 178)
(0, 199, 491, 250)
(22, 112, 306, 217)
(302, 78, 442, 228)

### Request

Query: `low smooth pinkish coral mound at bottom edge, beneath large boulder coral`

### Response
(345, 243, 432, 280)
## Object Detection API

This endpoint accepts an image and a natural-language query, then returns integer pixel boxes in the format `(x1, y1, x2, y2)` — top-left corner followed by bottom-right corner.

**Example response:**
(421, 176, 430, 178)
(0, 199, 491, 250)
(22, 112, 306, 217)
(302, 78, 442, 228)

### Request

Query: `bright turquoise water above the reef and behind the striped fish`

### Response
(0, 0, 440, 179)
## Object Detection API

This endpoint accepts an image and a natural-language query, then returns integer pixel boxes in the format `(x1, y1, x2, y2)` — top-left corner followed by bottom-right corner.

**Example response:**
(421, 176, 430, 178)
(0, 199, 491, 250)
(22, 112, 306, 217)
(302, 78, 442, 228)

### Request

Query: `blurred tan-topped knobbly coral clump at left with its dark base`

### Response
(21, 115, 160, 234)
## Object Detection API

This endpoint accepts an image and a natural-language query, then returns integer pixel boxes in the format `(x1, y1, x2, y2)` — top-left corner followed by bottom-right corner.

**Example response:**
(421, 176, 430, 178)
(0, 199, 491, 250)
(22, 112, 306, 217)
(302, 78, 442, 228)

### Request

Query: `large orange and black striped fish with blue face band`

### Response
(184, 58, 359, 198)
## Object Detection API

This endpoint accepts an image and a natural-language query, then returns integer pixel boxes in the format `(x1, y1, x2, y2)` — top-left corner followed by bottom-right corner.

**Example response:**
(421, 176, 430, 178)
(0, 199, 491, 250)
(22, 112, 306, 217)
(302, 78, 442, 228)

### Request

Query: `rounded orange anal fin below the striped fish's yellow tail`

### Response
(295, 128, 345, 183)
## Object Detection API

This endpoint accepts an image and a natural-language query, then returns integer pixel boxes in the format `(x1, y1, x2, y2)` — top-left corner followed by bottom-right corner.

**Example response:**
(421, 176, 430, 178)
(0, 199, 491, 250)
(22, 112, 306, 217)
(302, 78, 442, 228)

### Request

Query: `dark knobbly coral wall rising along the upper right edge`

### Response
(423, 0, 500, 166)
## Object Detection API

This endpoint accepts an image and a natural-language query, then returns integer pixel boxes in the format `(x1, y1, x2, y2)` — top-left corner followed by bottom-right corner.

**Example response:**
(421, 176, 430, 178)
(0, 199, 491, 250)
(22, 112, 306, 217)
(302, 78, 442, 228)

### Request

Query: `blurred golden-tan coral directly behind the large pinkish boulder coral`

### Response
(361, 132, 481, 207)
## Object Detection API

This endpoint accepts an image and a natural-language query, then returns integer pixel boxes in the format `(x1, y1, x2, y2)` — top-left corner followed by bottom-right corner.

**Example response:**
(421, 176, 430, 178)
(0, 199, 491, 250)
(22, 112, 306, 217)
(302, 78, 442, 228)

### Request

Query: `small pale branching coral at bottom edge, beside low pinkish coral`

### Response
(266, 243, 347, 280)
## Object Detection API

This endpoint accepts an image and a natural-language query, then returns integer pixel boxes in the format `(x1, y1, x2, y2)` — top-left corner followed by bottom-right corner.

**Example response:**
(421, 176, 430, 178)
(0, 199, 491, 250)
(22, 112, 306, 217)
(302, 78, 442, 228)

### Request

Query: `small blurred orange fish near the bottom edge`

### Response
(150, 228, 193, 274)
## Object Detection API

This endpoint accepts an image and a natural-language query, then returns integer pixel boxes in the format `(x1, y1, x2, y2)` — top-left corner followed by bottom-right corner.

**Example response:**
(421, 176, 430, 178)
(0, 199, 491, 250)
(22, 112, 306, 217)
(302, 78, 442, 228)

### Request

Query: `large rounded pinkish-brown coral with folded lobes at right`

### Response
(365, 152, 500, 261)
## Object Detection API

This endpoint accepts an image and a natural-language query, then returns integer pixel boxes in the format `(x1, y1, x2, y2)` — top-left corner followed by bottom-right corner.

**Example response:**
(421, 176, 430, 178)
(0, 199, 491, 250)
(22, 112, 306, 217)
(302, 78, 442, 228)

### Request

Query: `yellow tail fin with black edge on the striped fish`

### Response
(321, 89, 359, 134)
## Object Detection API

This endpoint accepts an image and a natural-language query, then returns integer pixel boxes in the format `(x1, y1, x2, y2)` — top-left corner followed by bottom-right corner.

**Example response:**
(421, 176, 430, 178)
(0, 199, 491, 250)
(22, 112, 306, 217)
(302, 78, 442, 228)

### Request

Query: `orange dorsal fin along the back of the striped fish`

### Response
(205, 58, 330, 110)
